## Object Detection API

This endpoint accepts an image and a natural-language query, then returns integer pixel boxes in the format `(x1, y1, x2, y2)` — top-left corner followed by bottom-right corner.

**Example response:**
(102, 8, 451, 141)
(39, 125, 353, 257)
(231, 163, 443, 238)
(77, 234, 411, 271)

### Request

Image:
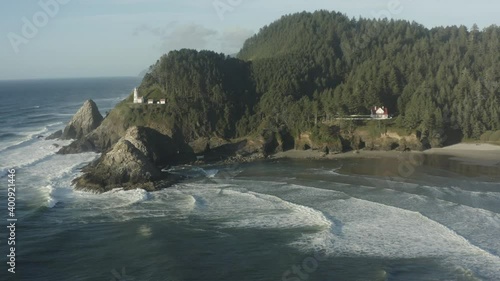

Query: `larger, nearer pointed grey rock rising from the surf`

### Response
(73, 139, 168, 192)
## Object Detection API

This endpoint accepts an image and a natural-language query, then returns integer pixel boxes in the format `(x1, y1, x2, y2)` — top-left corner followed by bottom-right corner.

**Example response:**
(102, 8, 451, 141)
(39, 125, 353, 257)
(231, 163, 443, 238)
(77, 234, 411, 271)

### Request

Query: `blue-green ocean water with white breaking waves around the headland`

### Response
(0, 78, 500, 281)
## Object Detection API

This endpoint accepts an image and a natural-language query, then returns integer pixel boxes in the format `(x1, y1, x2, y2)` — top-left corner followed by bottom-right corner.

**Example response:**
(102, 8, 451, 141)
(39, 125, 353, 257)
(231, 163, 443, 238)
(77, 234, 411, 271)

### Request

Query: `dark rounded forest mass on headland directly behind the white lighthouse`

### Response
(139, 49, 256, 140)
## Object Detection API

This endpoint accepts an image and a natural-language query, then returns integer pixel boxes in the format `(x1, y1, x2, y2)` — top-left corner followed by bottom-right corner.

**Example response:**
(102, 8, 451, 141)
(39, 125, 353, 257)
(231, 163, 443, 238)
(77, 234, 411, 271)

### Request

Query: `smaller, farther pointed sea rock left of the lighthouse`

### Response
(61, 100, 103, 140)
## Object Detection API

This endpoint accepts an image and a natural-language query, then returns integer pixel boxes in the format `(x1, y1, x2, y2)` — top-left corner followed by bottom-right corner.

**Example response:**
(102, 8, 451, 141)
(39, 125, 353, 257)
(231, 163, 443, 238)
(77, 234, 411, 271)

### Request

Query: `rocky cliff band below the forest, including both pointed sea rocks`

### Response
(59, 94, 426, 192)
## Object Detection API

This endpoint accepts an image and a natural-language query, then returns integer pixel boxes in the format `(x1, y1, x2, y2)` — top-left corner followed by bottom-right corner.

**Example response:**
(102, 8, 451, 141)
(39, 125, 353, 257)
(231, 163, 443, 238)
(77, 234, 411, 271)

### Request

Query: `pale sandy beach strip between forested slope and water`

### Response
(270, 143, 500, 166)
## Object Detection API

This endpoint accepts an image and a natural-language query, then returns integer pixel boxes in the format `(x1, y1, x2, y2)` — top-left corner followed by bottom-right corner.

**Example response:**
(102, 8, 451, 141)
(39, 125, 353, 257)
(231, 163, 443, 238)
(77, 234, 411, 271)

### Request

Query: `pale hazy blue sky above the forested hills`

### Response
(0, 0, 500, 80)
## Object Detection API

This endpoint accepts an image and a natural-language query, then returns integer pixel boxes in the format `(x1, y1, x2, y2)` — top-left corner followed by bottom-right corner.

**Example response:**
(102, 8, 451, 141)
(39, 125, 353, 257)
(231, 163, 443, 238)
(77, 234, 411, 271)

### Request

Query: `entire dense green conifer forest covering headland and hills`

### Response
(140, 11, 500, 146)
